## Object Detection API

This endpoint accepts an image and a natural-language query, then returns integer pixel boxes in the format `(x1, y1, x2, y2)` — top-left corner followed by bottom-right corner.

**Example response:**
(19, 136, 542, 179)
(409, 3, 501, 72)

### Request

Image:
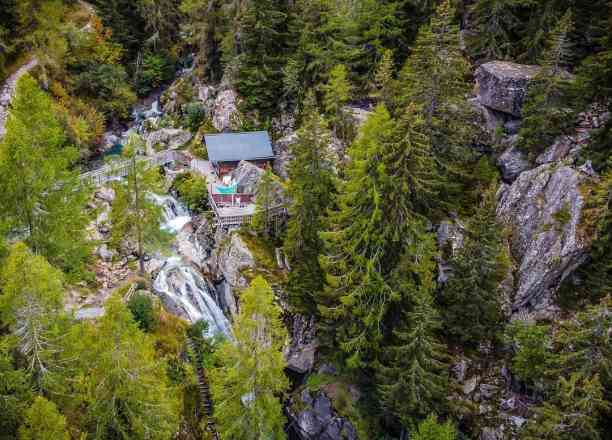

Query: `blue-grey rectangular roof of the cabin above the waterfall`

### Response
(204, 131, 274, 162)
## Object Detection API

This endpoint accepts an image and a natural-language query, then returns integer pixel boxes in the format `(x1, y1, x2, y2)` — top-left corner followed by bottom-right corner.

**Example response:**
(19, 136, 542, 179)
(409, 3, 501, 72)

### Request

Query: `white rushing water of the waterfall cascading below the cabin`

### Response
(150, 194, 231, 337)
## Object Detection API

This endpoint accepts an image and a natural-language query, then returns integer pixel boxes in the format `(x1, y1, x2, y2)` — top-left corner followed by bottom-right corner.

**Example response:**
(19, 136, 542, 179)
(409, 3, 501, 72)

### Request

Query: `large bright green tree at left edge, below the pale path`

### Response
(0, 75, 91, 274)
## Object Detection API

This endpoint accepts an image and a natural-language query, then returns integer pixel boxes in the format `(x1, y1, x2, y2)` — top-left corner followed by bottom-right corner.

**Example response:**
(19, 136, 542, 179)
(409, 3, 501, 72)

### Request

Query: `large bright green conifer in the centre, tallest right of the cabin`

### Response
(317, 105, 414, 367)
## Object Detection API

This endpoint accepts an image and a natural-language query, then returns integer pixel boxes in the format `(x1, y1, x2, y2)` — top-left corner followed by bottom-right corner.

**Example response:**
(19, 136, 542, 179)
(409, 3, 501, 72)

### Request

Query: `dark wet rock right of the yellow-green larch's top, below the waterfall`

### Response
(285, 315, 318, 374)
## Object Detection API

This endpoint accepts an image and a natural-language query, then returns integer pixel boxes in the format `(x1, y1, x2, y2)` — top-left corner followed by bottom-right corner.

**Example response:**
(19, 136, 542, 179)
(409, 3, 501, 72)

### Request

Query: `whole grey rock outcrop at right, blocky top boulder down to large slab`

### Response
(474, 61, 601, 317)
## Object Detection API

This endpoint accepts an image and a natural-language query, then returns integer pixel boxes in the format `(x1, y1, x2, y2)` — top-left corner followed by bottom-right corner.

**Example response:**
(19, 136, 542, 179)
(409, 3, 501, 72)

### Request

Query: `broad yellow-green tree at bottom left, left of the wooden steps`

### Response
(60, 296, 178, 440)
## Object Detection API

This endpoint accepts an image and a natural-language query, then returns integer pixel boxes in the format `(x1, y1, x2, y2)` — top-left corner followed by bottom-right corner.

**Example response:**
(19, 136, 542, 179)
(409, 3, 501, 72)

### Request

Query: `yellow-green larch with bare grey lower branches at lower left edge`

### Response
(0, 243, 63, 390)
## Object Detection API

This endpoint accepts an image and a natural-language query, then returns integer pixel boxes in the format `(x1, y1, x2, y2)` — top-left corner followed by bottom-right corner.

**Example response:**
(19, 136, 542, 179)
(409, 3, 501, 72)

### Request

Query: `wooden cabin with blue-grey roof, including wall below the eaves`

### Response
(204, 131, 274, 177)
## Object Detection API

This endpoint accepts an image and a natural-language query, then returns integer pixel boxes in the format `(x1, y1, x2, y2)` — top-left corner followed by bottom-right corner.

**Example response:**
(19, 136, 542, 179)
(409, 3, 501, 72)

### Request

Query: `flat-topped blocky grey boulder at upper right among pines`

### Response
(476, 61, 540, 117)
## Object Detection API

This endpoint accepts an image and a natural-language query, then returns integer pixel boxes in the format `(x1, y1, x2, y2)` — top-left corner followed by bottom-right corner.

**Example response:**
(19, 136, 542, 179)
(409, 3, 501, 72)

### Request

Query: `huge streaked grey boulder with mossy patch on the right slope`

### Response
(497, 164, 591, 314)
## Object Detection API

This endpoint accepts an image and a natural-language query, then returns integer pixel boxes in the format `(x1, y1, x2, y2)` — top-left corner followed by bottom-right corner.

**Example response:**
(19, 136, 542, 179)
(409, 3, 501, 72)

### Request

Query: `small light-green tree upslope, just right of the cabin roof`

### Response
(323, 64, 352, 141)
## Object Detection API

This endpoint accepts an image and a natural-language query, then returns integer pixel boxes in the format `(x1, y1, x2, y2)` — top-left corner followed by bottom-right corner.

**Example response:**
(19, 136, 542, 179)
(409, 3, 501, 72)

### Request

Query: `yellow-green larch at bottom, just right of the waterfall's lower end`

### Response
(211, 277, 289, 440)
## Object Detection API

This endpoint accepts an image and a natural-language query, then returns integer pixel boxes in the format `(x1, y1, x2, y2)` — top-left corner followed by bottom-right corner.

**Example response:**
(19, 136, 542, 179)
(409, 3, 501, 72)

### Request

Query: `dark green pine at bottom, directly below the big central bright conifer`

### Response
(377, 235, 448, 429)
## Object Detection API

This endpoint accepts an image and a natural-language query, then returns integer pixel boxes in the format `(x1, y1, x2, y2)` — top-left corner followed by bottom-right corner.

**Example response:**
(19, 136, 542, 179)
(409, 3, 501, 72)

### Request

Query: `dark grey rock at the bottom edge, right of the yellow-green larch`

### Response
(288, 389, 357, 440)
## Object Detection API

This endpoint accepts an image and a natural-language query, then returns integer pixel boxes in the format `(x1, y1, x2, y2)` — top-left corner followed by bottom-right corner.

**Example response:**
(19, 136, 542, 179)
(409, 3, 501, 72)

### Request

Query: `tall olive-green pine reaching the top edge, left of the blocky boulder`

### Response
(397, 0, 484, 210)
